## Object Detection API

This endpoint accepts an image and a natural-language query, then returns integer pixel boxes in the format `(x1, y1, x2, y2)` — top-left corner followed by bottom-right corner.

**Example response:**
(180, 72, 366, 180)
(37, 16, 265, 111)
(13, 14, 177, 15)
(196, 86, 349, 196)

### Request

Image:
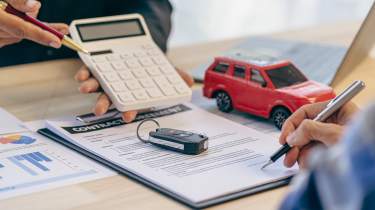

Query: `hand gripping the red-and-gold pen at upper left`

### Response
(0, 0, 68, 48)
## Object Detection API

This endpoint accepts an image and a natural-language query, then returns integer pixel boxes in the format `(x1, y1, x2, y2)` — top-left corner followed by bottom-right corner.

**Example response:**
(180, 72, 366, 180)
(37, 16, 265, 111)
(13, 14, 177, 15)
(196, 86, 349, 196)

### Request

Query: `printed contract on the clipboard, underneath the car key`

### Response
(46, 103, 297, 207)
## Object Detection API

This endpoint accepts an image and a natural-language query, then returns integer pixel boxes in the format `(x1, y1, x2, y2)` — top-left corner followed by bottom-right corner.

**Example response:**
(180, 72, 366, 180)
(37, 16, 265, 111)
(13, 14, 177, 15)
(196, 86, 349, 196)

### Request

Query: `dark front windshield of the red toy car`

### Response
(266, 65, 307, 88)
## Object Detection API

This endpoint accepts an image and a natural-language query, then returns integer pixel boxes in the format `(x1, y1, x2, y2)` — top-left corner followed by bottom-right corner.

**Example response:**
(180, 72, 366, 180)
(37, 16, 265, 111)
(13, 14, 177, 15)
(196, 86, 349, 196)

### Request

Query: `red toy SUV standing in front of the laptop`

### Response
(203, 57, 335, 129)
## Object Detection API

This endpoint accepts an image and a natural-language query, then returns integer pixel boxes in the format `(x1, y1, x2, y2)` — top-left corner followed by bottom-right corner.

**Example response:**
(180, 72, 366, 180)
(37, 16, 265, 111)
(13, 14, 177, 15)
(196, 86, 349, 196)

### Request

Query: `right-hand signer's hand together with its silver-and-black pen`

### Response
(262, 81, 365, 168)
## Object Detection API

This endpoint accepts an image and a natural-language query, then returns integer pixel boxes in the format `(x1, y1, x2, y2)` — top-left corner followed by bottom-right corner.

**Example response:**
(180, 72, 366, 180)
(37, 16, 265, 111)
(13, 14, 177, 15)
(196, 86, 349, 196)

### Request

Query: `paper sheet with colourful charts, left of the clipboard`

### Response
(0, 122, 116, 200)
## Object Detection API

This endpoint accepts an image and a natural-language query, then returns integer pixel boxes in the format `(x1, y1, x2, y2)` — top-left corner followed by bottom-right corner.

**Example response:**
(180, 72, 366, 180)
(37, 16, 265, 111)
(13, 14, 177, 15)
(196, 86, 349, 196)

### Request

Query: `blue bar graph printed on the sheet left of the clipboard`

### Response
(7, 152, 52, 176)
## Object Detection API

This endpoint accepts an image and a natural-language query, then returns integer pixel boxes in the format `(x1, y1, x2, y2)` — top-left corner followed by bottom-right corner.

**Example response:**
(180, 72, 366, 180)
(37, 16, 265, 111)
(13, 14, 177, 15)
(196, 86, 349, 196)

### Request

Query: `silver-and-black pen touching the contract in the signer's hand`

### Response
(261, 81, 365, 169)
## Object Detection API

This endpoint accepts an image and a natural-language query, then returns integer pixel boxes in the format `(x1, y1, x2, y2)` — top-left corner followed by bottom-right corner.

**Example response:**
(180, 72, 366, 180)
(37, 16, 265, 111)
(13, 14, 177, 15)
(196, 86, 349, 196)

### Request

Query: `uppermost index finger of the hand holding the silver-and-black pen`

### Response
(279, 102, 329, 144)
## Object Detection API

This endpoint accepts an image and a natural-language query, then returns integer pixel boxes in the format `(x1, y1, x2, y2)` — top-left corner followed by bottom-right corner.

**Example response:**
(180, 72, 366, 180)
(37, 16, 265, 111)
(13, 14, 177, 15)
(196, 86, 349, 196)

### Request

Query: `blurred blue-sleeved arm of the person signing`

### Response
(281, 105, 375, 210)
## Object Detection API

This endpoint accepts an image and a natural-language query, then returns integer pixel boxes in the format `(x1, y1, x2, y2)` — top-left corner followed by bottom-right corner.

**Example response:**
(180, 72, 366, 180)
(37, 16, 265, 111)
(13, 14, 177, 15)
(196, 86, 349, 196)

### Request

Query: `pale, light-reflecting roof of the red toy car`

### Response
(217, 52, 289, 66)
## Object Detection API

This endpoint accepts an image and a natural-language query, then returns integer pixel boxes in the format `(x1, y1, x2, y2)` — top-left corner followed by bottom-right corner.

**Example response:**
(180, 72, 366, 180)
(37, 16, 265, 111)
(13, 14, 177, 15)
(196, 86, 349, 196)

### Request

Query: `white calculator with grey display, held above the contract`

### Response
(70, 14, 192, 112)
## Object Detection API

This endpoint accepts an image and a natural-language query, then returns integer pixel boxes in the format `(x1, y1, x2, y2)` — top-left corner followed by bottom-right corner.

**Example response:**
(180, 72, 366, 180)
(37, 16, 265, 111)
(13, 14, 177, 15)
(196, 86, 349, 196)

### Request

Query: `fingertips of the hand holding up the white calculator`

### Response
(75, 66, 194, 122)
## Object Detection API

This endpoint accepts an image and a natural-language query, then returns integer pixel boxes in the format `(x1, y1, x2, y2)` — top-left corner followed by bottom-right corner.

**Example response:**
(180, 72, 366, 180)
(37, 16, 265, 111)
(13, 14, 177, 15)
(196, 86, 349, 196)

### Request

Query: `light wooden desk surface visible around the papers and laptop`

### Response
(0, 23, 375, 210)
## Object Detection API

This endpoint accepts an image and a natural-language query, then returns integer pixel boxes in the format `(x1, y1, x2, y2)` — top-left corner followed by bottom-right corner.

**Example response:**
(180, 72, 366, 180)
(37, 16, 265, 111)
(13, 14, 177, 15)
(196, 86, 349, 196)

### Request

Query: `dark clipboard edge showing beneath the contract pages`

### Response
(38, 128, 292, 209)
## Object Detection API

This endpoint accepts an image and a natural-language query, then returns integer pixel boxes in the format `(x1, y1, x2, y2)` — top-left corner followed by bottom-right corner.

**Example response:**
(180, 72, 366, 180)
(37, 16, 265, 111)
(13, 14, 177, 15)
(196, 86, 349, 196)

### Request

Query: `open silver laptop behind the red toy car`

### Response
(192, 3, 375, 85)
